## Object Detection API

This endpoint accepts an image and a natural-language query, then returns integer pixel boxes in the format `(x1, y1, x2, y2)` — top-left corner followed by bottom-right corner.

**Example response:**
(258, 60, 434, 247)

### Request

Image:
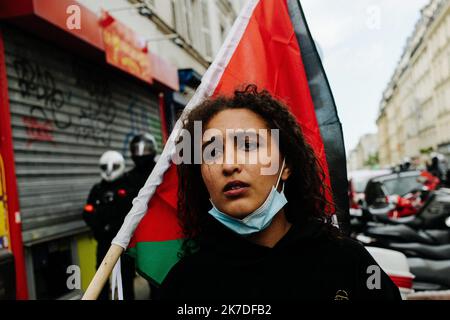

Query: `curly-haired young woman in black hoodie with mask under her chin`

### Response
(157, 85, 400, 301)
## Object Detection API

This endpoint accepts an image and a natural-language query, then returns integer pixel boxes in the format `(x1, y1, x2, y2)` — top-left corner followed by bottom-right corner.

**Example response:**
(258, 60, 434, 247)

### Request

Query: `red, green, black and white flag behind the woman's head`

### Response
(113, 0, 348, 283)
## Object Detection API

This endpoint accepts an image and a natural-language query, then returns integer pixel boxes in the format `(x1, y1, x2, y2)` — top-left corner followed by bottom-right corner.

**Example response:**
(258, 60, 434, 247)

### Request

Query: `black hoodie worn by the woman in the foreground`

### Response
(155, 218, 401, 301)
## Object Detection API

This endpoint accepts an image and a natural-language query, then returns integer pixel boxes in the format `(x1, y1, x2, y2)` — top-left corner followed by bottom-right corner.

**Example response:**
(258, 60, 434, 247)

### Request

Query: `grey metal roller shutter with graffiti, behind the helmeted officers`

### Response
(3, 26, 161, 245)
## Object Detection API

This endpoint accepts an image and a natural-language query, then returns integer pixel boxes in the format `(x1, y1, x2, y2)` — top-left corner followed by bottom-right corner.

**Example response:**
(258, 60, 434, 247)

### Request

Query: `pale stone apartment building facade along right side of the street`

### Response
(377, 0, 450, 166)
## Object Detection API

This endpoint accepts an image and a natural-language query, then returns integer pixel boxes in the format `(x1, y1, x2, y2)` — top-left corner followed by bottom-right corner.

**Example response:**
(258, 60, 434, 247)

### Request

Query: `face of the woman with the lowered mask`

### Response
(201, 108, 290, 219)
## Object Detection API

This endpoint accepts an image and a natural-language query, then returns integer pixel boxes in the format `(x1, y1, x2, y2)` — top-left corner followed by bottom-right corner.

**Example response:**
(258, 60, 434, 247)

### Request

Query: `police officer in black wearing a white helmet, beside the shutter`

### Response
(83, 151, 135, 300)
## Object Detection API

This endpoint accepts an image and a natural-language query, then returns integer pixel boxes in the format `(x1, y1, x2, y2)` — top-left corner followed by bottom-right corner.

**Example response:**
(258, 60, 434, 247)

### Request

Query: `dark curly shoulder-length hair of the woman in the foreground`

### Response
(177, 84, 335, 253)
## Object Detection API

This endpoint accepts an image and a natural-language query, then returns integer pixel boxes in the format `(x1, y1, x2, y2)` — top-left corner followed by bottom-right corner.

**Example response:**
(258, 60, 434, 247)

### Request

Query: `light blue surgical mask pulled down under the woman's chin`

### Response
(208, 160, 287, 235)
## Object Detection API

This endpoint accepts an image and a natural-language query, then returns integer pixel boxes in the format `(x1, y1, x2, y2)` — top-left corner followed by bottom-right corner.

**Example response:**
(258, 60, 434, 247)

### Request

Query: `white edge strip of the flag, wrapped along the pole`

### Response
(112, 0, 260, 249)
